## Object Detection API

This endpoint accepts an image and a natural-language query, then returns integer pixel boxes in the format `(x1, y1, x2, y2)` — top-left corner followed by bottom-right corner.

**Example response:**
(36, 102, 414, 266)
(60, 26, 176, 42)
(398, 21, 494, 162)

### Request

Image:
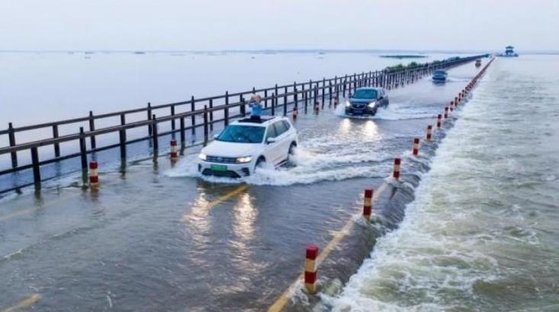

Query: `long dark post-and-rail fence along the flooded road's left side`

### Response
(0, 55, 485, 193)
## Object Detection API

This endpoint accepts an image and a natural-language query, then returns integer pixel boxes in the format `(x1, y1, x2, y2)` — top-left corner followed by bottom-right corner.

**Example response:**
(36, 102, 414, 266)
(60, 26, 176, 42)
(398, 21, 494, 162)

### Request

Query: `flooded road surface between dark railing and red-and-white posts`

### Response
(0, 64, 477, 311)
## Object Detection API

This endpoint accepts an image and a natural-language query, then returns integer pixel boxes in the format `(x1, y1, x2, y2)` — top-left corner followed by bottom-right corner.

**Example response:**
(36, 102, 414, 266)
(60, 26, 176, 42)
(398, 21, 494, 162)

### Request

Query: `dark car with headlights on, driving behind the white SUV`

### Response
(345, 88, 388, 116)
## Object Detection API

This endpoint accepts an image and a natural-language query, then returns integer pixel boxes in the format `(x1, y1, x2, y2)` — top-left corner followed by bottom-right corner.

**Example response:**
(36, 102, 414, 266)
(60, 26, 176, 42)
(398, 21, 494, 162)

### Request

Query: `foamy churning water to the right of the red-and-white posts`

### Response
(325, 55, 559, 311)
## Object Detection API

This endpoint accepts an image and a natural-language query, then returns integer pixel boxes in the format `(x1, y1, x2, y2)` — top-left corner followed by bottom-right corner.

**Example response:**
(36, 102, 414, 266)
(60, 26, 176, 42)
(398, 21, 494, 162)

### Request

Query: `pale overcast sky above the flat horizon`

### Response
(0, 0, 559, 51)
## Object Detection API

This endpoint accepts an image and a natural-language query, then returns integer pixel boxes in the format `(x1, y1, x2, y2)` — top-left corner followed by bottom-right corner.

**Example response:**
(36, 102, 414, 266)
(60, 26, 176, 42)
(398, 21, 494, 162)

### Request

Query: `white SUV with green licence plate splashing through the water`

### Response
(198, 117, 297, 178)
